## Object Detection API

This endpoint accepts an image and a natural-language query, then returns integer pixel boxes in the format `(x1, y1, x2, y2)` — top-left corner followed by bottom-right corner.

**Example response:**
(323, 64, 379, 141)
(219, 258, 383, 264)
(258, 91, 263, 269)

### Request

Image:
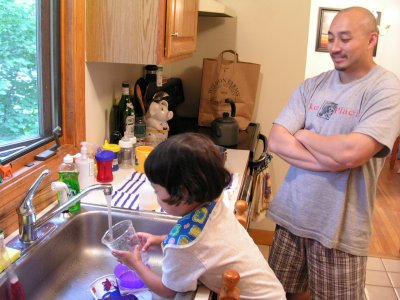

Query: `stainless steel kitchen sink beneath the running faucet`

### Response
(0, 203, 186, 300)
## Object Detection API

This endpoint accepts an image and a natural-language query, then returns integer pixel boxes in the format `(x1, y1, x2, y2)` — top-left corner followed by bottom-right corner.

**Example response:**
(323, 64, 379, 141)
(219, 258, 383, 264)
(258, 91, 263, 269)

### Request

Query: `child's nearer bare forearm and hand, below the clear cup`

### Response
(112, 246, 176, 298)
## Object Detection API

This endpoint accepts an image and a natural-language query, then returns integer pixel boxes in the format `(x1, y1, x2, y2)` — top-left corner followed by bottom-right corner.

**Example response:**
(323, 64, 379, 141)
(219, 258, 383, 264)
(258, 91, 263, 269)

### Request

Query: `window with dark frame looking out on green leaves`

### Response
(0, 0, 61, 164)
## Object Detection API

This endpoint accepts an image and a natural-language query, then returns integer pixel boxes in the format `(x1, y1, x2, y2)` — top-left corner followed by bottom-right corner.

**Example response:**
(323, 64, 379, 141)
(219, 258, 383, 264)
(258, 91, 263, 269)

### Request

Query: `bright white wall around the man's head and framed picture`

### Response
(305, 0, 400, 78)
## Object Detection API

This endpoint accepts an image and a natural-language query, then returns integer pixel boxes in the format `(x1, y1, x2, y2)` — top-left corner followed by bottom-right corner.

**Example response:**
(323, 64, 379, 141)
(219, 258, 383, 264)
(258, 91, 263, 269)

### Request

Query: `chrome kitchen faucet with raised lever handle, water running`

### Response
(17, 170, 112, 244)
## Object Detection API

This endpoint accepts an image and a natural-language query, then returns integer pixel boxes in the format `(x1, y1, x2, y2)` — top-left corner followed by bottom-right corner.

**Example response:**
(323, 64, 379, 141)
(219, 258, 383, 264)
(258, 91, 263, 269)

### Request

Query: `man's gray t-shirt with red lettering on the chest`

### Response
(269, 66, 400, 256)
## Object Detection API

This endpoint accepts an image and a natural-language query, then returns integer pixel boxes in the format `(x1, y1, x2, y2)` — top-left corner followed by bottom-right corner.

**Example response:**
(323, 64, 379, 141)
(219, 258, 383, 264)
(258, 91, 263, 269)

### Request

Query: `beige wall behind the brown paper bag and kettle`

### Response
(165, 0, 310, 192)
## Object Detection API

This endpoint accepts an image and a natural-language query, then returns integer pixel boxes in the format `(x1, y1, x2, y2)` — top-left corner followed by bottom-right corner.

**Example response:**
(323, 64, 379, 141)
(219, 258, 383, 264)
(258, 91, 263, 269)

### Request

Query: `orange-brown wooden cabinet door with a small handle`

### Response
(164, 0, 198, 58)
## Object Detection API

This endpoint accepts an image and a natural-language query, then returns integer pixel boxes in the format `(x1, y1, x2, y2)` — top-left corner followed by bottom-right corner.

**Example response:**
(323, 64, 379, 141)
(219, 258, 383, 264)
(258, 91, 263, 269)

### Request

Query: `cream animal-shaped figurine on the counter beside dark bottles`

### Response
(146, 100, 174, 147)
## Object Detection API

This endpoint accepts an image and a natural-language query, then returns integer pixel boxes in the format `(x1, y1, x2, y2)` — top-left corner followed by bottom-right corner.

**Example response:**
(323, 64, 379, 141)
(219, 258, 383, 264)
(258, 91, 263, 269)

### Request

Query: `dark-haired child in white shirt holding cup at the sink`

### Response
(113, 133, 286, 300)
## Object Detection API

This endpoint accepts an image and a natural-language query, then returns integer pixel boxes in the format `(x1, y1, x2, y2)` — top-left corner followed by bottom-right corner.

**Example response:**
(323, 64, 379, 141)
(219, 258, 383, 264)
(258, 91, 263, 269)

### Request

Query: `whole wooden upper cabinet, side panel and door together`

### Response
(86, 0, 198, 64)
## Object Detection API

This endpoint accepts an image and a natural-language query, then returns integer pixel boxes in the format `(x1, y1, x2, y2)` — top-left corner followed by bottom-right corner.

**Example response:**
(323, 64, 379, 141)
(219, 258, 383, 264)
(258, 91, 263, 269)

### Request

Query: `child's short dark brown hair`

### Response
(144, 133, 232, 205)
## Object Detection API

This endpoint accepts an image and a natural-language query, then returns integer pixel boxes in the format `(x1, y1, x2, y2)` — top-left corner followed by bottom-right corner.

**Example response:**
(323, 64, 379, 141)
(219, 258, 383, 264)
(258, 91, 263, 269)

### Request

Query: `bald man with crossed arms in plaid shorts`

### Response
(269, 7, 400, 300)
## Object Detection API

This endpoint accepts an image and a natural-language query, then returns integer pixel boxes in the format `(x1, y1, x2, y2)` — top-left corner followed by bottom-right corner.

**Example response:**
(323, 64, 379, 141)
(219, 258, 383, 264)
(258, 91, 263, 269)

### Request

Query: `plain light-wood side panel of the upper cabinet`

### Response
(86, 0, 160, 64)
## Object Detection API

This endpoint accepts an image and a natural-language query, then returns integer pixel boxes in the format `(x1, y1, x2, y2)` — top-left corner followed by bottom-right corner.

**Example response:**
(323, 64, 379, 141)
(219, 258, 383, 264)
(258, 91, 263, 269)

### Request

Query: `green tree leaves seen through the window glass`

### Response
(0, 0, 39, 145)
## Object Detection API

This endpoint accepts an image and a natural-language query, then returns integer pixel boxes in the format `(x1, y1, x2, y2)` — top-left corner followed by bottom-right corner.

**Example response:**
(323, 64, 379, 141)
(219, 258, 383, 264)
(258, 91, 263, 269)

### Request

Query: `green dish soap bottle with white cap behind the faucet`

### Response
(58, 154, 81, 212)
